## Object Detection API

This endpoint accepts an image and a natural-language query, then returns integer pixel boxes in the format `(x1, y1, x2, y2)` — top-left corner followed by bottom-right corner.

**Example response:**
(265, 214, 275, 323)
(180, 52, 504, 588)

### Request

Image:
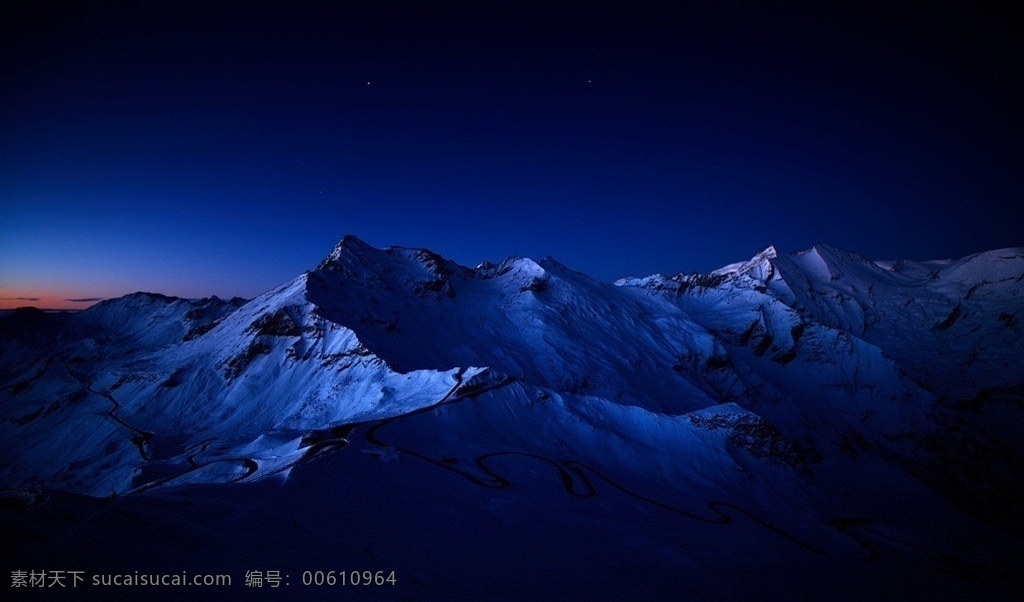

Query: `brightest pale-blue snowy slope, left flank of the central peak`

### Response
(0, 275, 477, 496)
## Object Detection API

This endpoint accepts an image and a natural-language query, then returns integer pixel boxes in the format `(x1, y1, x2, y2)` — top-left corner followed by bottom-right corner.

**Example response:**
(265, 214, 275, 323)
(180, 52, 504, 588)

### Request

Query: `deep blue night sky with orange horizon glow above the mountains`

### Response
(0, 2, 1024, 307)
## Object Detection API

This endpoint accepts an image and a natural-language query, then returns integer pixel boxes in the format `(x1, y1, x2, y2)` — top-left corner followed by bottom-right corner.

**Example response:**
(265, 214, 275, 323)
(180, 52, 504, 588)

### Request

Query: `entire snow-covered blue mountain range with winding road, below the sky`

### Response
(0, 237, 1024, 599)
